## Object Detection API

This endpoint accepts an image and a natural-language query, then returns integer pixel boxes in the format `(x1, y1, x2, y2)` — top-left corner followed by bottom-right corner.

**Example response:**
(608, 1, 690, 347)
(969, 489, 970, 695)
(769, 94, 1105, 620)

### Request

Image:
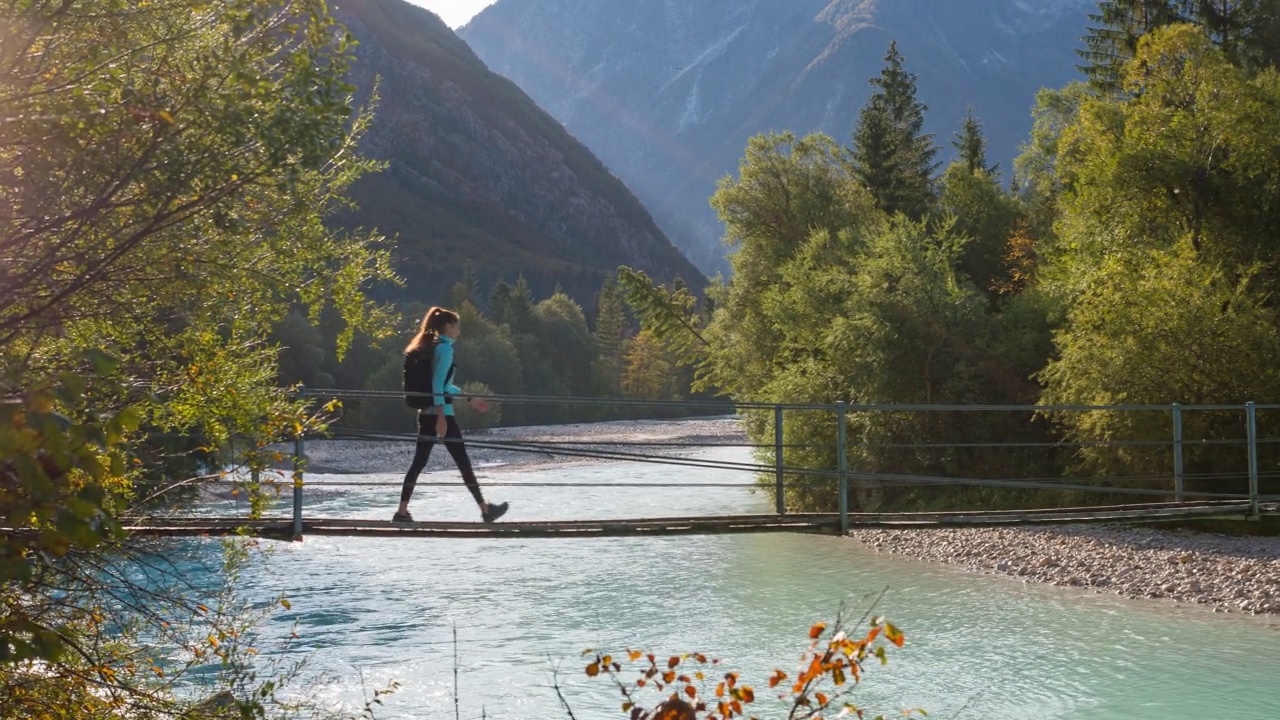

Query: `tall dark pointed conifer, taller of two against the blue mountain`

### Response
(852, 42, 938, 220)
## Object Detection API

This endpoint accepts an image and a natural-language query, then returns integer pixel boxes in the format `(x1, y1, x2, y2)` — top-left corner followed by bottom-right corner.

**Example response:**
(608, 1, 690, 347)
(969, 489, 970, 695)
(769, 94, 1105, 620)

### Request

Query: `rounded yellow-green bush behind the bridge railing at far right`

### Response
(1042, 245, 1280, 492)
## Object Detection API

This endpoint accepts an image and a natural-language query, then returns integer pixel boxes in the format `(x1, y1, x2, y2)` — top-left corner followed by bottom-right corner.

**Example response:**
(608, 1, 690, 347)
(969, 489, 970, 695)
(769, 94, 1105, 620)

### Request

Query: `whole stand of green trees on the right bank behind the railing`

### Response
(622, 1, 1280, 510)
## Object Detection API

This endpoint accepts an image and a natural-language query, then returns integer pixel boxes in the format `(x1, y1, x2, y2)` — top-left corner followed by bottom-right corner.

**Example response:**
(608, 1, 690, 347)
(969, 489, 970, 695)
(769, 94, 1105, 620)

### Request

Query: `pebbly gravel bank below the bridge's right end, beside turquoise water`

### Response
(852, 525, 1280, 615)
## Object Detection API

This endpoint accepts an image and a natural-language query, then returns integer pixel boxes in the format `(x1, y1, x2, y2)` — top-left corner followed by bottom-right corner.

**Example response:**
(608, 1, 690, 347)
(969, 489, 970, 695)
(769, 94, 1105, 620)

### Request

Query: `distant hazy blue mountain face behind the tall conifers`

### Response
(460, 0, 1096, 272)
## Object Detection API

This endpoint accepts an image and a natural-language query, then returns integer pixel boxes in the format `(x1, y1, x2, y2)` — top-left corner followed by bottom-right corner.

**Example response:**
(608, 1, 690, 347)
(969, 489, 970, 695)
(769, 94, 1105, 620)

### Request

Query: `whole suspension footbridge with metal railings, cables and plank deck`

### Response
(123, 389, 1280, 539)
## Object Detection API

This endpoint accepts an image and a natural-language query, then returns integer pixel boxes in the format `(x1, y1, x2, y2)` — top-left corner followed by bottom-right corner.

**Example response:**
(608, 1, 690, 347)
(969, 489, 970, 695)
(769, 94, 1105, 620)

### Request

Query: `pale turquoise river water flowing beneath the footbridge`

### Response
(172, 450, 1280, 720)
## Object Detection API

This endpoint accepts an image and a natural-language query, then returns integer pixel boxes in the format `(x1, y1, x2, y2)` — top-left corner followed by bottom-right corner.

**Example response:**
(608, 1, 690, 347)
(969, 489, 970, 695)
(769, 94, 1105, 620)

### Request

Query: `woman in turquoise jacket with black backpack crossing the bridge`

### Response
(392, 307, 507, 523)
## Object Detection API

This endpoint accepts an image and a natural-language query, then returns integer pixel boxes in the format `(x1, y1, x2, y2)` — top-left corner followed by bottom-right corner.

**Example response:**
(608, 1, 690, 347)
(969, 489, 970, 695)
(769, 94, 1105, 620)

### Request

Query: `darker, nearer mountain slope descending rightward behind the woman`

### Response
(334, 0, 705, 304)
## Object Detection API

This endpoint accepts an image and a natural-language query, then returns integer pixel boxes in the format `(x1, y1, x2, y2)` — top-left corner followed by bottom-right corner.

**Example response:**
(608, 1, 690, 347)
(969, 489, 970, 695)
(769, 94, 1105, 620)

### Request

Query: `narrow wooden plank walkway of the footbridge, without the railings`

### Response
(115, 501, 1280, 539)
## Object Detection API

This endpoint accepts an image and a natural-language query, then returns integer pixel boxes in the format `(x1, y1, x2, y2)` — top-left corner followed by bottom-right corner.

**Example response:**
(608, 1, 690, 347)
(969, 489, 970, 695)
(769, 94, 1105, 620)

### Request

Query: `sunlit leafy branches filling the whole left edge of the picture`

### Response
(0, 0, 394, 720)
